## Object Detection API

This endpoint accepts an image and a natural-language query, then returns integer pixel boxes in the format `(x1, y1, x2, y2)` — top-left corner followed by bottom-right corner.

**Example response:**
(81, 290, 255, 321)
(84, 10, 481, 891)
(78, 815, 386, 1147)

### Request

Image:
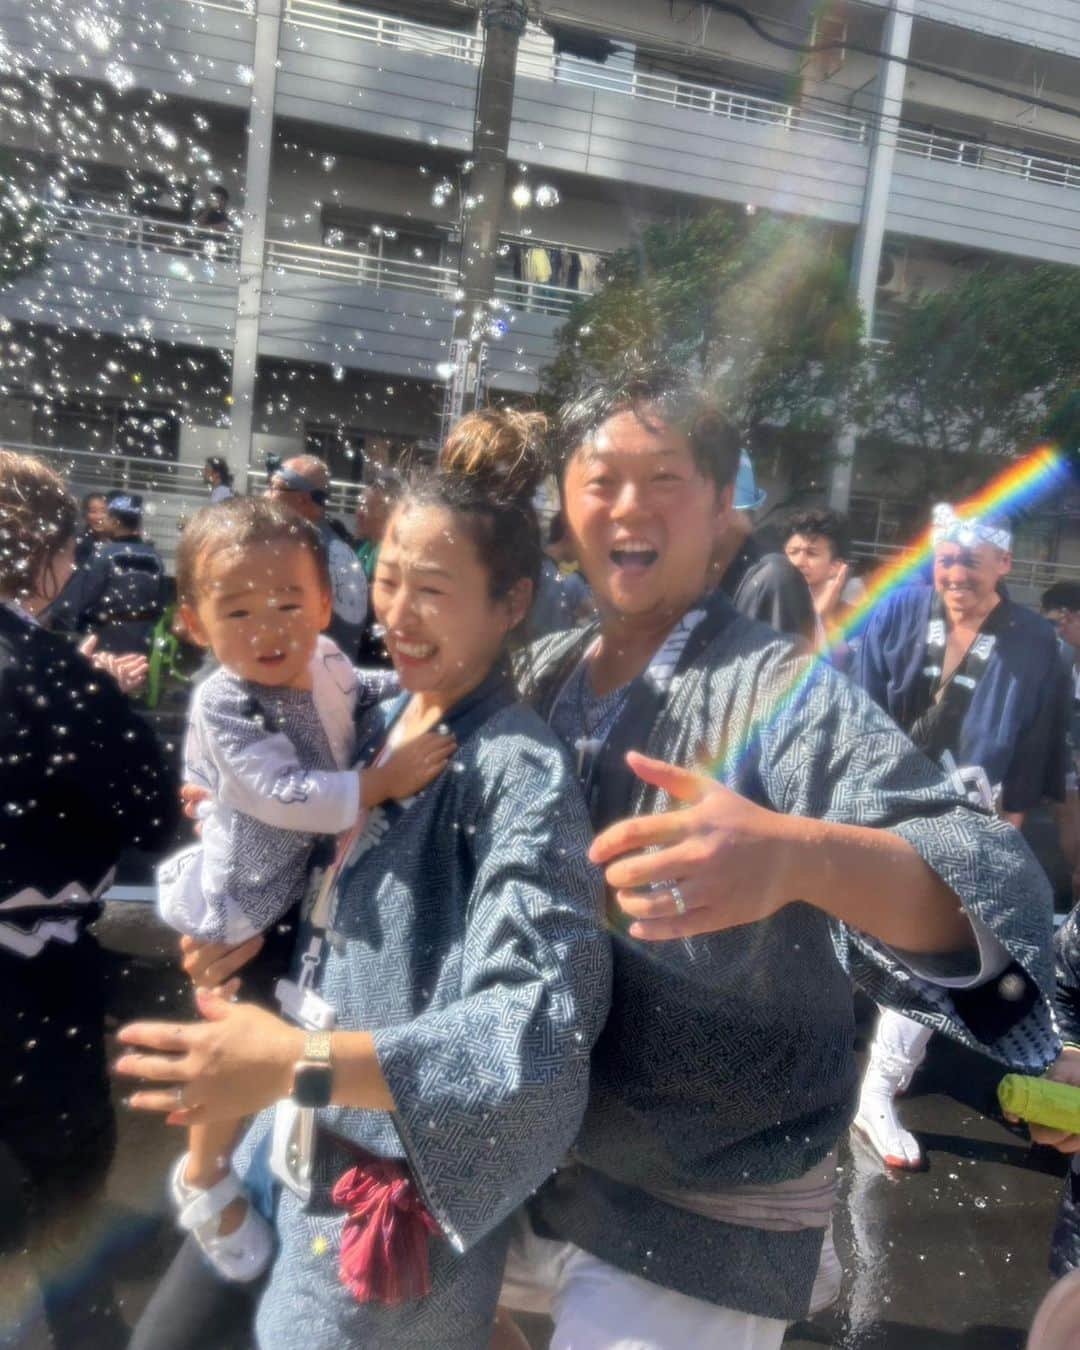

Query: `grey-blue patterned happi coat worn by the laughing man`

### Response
(521, 601, 1057, 1319)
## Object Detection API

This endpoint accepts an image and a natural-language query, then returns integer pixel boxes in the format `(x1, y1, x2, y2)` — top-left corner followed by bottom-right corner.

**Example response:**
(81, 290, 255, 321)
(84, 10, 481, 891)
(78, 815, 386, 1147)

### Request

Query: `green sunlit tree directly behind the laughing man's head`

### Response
(541, 209, 861, 490)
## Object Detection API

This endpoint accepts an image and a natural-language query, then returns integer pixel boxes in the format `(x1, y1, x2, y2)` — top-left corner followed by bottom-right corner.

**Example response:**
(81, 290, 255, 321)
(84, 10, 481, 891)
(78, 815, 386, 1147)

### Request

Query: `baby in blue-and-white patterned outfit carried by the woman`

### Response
(158, 498, 454, 1280)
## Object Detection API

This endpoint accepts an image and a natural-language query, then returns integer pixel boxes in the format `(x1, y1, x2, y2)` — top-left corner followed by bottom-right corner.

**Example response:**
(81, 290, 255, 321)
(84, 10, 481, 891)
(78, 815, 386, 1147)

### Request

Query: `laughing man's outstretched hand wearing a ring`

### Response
(589, 753, 795, 942)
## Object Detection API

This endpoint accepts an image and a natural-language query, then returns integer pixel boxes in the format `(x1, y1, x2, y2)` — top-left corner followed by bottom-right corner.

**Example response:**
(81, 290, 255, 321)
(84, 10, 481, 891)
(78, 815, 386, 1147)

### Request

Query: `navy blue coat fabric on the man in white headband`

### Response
(852, 586, 1068, 811)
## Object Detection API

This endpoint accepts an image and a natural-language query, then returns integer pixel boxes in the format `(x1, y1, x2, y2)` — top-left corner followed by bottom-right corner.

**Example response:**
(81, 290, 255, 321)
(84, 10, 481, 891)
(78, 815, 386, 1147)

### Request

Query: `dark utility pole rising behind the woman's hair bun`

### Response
(443, 0, 527, 431)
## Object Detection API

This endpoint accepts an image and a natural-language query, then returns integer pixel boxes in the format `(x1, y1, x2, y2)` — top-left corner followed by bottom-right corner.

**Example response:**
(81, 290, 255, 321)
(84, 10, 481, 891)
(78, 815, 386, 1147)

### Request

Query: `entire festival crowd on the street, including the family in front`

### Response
(0, 367, 1080, 1350)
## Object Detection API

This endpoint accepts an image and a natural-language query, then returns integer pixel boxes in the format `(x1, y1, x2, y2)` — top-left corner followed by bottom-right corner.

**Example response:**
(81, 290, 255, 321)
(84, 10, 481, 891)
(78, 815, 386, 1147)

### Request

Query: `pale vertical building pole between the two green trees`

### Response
(829, 0, 914, 512)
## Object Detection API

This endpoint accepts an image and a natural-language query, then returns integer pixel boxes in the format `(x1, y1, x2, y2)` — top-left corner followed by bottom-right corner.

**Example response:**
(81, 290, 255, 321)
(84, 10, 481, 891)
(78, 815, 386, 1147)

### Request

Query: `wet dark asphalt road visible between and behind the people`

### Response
(0, 906, 1080, 1350)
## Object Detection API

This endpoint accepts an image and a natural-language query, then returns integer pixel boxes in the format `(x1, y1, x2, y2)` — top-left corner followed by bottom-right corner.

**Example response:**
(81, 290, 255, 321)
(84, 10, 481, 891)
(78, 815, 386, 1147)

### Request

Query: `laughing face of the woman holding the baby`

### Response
(373, 502, 532, 706)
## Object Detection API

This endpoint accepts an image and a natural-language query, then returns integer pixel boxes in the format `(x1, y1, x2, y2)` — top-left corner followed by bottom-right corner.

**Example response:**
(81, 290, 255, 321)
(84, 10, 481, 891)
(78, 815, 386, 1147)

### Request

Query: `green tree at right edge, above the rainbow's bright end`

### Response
(860, 263, 1080, 502)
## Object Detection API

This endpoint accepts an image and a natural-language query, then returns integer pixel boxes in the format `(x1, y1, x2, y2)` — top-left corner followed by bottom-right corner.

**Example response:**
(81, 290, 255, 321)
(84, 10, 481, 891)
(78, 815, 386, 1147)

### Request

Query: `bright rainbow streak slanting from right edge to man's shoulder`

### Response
(702, 441, 1069, 778)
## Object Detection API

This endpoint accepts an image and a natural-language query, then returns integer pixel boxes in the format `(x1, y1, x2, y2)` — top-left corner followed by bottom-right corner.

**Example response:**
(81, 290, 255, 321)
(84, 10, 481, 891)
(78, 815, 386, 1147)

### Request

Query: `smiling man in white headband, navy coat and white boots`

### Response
(852, 504, 1068, 1168)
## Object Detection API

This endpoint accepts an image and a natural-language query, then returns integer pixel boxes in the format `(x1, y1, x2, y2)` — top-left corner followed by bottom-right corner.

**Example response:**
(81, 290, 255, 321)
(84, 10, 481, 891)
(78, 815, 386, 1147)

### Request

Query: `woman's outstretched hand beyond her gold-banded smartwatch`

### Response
(115, 990, 304, 1126)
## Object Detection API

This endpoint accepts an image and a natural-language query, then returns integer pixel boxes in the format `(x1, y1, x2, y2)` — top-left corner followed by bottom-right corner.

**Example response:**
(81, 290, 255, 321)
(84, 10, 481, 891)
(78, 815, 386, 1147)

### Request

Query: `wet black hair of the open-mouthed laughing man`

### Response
(554, 363, 740, 487)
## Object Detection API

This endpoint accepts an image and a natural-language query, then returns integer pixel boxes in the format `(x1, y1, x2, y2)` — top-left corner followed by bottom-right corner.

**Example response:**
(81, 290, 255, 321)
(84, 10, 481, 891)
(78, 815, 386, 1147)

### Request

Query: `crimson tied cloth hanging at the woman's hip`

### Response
(332, 1157, 439, 1307)
